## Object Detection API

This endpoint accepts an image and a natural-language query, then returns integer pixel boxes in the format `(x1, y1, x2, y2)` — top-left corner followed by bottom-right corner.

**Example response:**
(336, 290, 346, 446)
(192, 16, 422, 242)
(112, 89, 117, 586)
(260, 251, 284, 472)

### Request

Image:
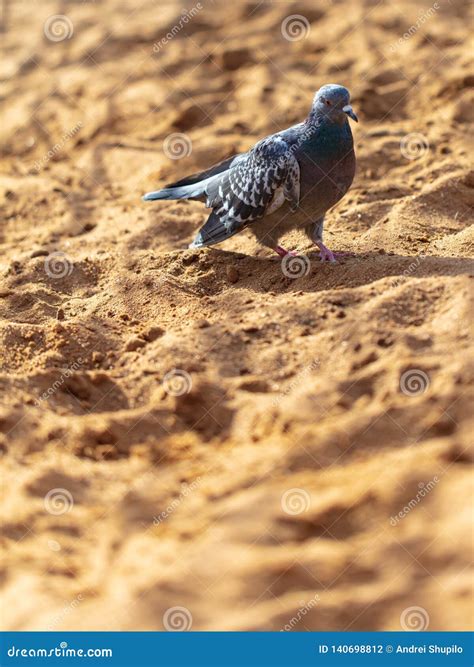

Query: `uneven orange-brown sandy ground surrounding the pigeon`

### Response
(0, 0, 474, 630)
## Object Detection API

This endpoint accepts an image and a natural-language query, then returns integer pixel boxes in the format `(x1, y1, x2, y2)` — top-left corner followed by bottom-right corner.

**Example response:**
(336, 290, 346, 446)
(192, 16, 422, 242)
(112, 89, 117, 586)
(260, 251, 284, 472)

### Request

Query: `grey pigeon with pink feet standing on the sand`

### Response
(143, 84, 358, 262)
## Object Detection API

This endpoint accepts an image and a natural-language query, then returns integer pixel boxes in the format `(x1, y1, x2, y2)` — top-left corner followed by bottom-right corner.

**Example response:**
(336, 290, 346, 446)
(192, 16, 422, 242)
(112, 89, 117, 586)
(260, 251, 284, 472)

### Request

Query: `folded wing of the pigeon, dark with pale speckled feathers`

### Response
(192, 135, 300, 247)
